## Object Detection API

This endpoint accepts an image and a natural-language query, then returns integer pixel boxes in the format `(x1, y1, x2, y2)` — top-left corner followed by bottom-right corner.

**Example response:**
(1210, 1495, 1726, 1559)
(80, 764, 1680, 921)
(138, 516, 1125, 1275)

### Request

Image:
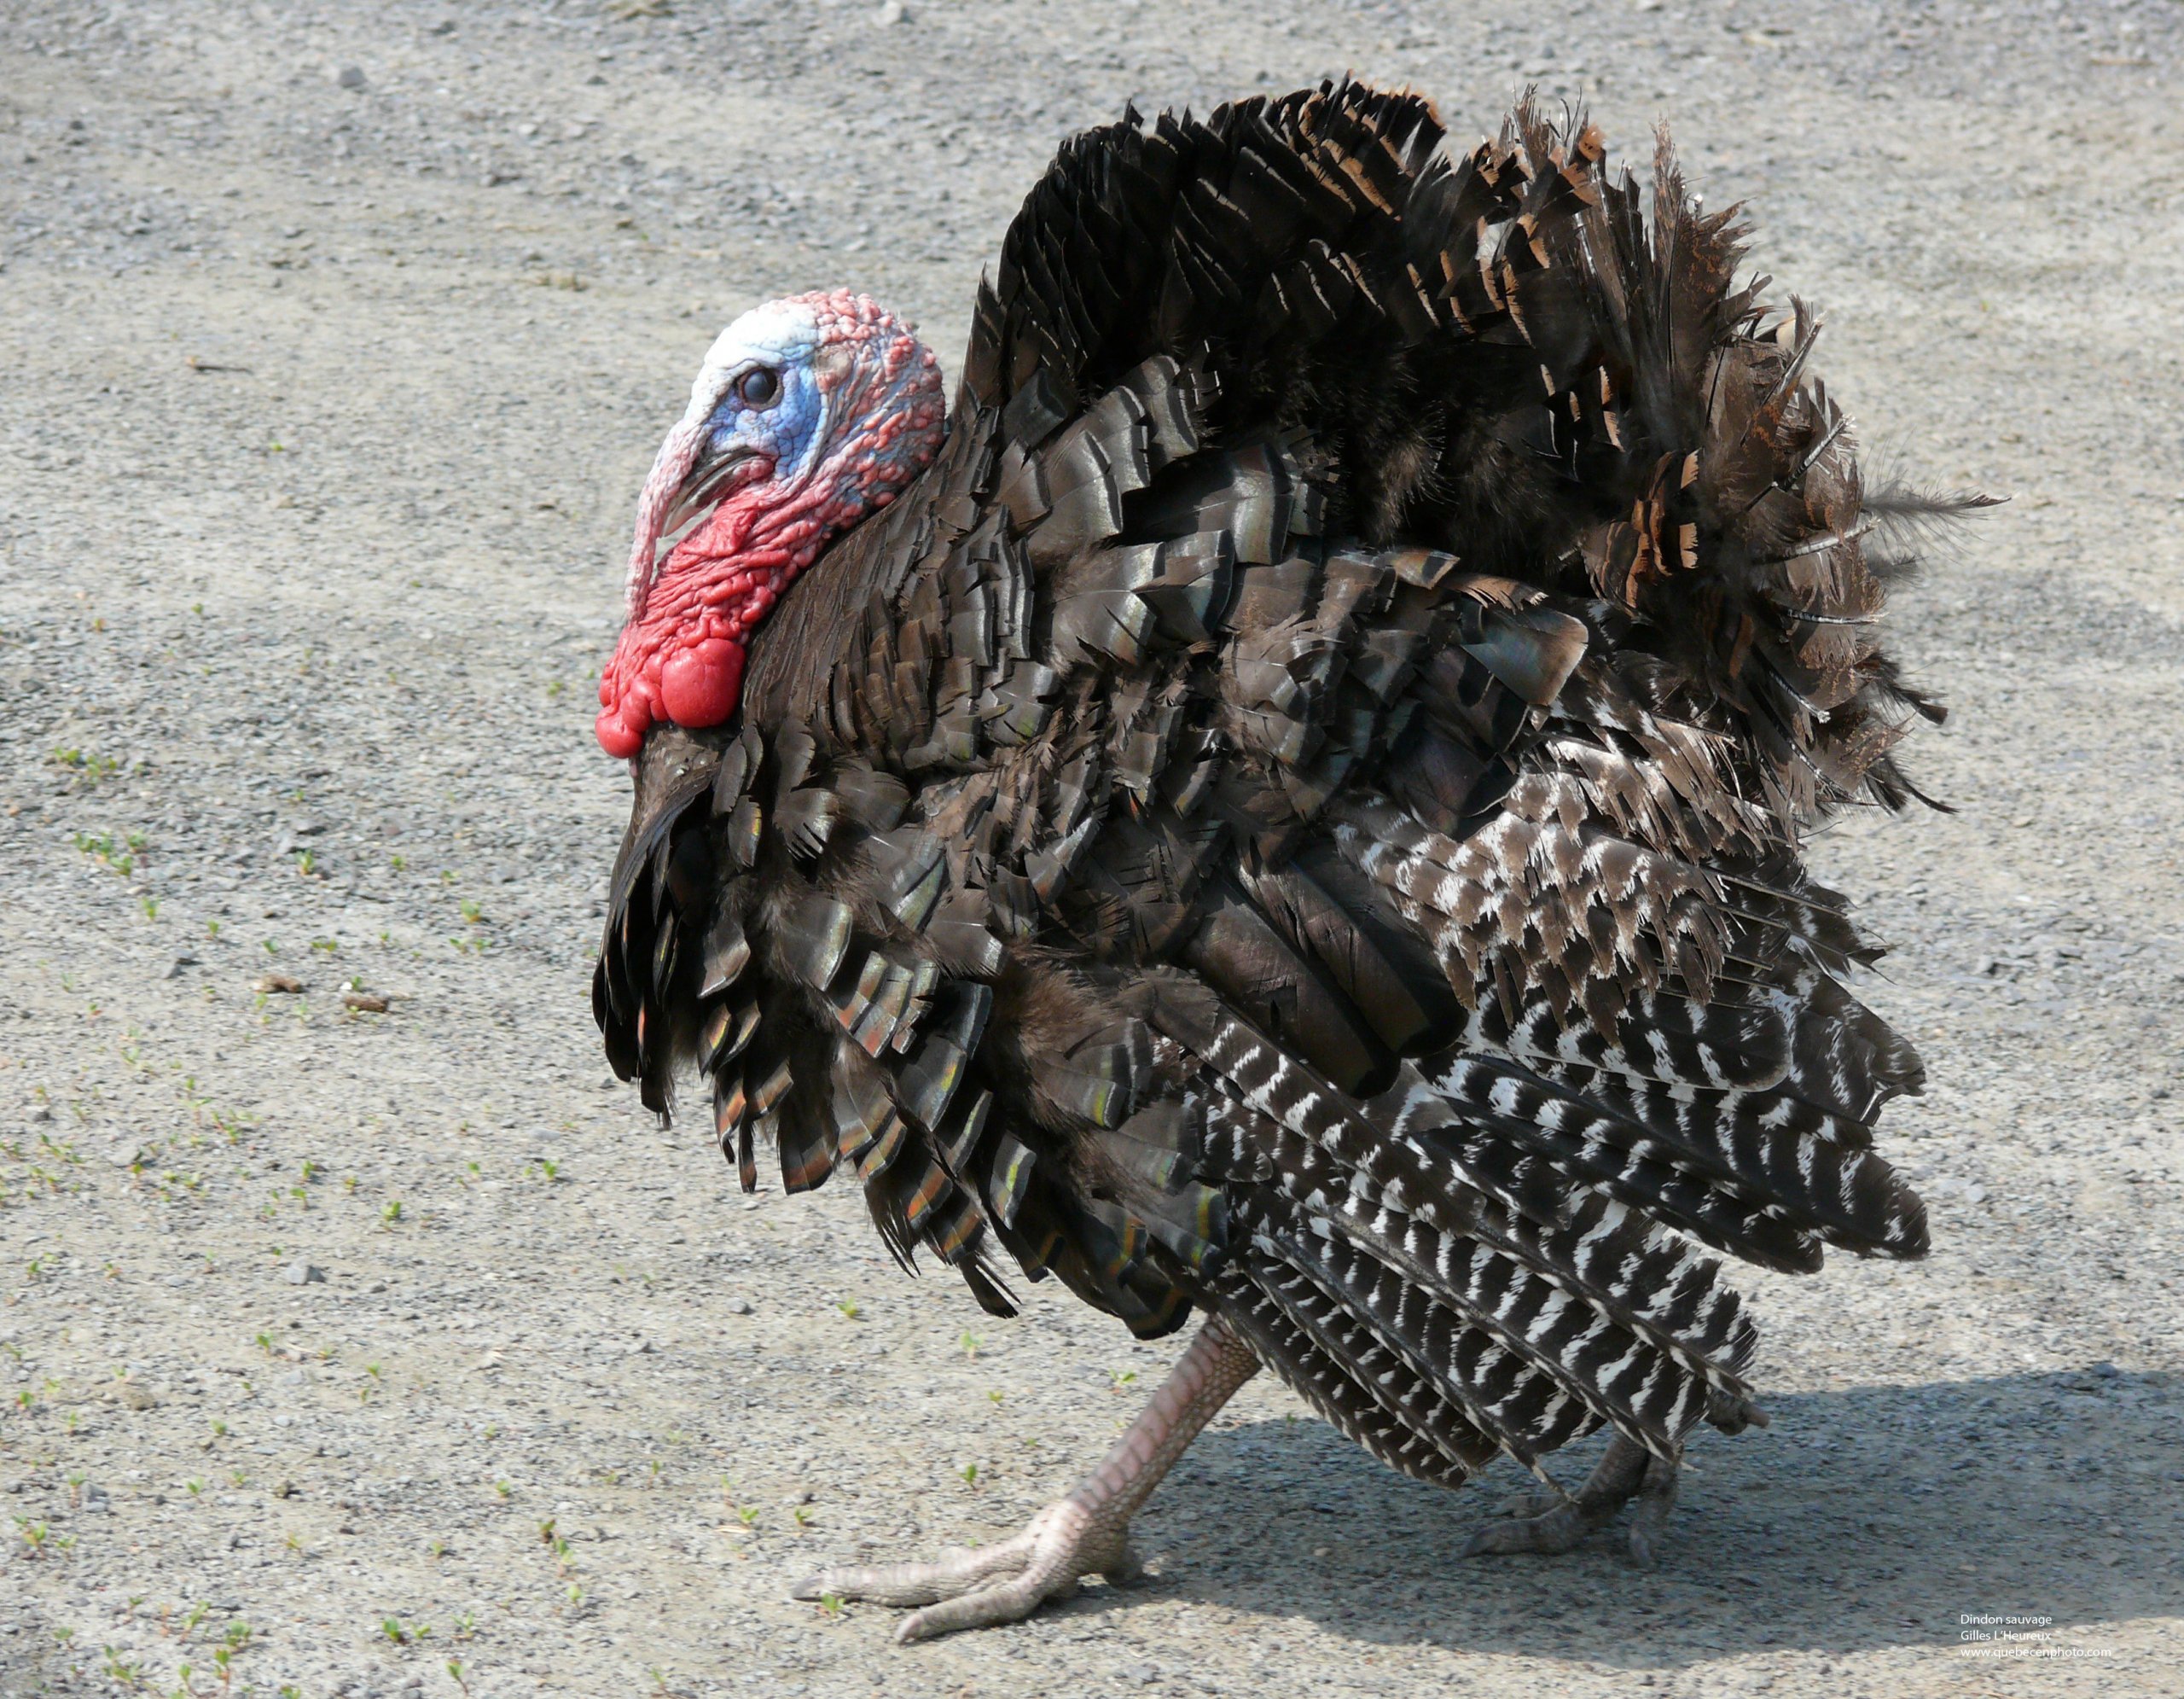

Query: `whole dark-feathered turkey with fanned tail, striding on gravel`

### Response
(592, 83, 1949, 1638)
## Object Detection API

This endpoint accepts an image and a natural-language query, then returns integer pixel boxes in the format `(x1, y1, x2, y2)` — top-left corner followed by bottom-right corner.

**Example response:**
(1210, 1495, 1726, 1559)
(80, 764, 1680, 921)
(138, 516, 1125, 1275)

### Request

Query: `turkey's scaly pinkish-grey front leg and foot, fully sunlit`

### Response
(795, 1317, 1258, 1644)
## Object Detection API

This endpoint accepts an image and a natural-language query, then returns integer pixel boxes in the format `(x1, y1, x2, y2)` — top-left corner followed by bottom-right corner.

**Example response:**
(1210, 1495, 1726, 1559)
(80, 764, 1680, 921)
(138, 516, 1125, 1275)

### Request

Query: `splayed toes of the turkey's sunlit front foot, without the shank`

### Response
(793, 1498, 1138, 1644)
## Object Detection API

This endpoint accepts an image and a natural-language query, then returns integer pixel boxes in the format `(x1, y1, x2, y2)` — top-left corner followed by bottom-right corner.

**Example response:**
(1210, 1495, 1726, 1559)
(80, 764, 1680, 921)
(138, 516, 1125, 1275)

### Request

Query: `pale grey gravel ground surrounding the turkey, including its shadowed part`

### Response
(0, 0, 2184, 1699)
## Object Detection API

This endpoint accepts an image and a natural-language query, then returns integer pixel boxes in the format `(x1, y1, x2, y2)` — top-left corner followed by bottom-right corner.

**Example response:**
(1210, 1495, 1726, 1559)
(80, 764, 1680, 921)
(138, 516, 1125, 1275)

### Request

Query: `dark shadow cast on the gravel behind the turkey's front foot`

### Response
(1072, 1363, 2184, 1671)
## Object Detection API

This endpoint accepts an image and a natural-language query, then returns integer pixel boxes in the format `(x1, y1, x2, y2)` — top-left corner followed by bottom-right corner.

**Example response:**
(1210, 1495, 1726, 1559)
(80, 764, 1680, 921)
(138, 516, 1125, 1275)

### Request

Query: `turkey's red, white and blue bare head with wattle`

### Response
(596, 290, 941, 758)
